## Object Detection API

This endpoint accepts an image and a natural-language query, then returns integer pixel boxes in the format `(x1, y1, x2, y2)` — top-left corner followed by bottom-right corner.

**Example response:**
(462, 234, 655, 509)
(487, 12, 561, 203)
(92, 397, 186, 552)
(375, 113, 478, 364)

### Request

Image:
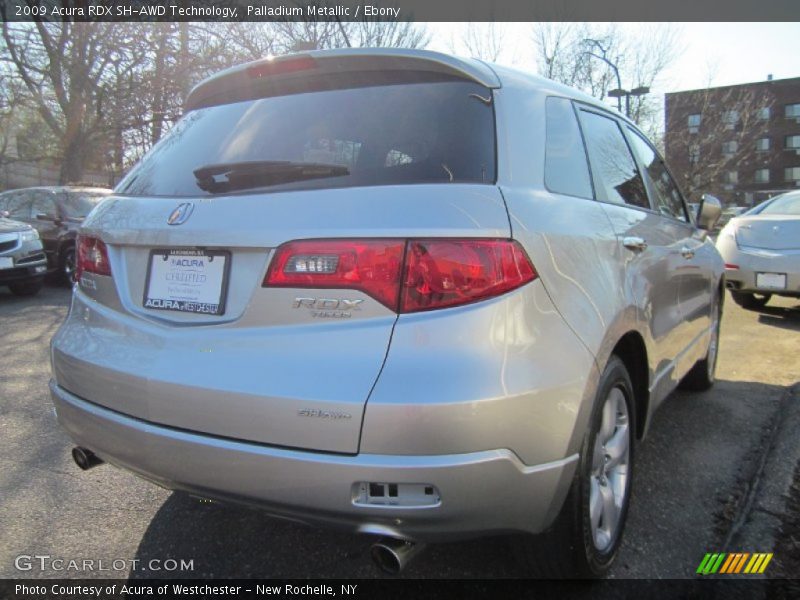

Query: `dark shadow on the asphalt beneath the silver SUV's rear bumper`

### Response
(130, 492, 525, 579)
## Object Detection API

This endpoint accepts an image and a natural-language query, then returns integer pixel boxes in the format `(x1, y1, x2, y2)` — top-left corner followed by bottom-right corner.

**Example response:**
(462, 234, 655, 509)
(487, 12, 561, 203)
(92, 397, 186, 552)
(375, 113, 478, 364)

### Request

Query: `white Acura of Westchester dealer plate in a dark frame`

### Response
(143, 249, 231, 315)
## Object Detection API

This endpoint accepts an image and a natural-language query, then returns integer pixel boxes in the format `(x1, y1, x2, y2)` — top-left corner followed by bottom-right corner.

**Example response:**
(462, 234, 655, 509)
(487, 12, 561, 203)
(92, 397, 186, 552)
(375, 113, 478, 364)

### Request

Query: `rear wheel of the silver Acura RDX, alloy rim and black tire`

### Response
(516, 356, 636, 578)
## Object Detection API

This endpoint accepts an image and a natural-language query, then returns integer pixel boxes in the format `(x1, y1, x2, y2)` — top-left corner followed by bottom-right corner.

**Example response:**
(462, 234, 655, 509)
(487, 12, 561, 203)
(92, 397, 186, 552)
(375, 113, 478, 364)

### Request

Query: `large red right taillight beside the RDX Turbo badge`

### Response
(264, 239, 537, 313)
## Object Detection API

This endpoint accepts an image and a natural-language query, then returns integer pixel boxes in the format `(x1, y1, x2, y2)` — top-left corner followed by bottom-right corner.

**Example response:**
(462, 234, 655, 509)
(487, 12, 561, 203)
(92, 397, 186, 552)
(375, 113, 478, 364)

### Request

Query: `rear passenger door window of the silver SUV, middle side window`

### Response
(580, 110, 650, 208)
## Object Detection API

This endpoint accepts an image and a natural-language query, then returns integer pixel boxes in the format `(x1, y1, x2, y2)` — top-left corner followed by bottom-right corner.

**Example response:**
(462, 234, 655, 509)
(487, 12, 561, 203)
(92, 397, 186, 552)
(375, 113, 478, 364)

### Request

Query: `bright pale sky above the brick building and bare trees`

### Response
(428, 23, 800, 94)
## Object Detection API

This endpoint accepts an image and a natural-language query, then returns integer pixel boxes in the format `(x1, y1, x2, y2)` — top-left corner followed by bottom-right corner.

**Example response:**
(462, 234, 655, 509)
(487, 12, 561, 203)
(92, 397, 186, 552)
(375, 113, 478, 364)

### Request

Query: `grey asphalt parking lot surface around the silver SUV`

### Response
(0, 285, 800, 579)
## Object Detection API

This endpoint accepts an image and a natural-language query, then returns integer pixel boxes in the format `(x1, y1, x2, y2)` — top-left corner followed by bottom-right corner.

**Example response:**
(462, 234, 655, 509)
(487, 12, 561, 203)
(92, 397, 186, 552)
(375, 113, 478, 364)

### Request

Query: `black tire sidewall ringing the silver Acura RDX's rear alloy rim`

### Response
(576, 356, 636, 577)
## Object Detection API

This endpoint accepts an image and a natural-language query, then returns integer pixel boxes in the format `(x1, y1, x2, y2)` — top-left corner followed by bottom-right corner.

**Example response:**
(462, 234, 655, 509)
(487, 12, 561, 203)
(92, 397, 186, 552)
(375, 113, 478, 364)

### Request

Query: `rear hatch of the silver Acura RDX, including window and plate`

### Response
(65, 54, 510, 453)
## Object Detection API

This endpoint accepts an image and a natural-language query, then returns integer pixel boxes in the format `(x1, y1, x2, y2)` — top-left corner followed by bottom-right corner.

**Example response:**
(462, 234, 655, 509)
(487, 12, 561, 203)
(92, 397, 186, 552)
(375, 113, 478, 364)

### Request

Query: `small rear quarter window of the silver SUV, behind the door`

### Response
(544, 97, 594, 198)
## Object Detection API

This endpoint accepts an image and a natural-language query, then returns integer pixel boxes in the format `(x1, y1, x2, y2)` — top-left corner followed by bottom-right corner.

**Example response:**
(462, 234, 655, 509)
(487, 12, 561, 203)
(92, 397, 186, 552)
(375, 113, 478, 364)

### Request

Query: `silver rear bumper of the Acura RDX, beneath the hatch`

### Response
(50, 381, 578, 541)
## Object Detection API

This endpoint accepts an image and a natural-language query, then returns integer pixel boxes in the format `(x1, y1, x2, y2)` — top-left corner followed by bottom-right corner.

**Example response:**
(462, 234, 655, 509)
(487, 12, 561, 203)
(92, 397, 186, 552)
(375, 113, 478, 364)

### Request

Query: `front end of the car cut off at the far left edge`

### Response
(0, 212, 47, 296)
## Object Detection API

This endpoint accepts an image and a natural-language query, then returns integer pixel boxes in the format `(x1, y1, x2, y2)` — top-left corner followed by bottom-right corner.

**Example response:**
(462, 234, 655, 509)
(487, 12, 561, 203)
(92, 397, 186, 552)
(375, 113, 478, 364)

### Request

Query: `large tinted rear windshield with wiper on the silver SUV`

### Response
(116, 81, 495, 196)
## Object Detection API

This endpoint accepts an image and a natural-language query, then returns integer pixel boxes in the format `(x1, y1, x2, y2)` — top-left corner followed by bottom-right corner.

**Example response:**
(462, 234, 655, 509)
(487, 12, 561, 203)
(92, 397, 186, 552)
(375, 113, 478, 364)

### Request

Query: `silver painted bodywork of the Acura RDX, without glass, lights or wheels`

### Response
(51, 51, 723, 540)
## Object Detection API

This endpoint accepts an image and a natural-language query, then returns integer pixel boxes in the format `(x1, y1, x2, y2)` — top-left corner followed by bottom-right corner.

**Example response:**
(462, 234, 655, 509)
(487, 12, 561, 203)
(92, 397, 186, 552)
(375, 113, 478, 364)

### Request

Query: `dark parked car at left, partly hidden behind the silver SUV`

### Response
(0, 187, 111, 282)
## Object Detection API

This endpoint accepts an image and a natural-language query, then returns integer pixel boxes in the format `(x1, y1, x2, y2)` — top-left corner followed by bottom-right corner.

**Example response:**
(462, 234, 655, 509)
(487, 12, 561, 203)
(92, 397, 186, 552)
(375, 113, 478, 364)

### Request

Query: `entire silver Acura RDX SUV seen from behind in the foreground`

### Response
(51, 50, 724, 575)
